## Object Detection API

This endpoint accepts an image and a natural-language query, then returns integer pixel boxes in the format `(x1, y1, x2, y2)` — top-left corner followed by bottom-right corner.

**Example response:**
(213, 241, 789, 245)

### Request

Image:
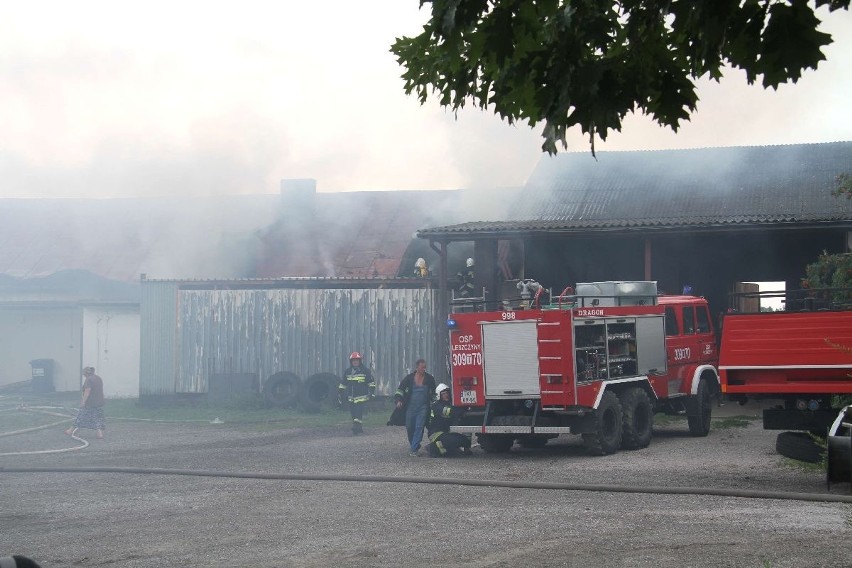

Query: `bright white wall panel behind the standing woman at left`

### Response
(83, 306, 139, 397)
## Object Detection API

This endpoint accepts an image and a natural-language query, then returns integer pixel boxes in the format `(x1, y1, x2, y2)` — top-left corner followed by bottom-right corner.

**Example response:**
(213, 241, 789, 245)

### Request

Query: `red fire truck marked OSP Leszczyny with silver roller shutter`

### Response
(447, 281, 719, 455)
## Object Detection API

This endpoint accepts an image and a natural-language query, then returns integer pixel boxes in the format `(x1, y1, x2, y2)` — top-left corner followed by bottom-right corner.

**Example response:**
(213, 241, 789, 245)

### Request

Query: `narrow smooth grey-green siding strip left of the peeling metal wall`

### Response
(139, 281, 178, 396)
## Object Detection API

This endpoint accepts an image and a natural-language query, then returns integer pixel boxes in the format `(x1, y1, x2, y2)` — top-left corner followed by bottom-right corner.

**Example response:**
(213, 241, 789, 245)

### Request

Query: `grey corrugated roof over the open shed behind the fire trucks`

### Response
(419, 142, 852, 237)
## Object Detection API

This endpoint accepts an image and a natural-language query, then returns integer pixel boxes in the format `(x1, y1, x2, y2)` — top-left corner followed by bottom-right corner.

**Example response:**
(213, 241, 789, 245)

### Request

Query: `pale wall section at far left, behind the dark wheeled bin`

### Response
(0, 307, 83, 391)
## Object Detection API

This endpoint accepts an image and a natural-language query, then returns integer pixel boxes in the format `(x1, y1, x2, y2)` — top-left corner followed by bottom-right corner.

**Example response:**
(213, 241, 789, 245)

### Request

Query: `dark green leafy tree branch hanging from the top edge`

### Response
(391, 0, 850, 154)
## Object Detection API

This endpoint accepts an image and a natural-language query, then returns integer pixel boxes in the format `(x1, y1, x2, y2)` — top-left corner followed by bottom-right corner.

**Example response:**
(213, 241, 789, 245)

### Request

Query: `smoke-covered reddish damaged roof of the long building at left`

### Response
(0, 186, 500, 282)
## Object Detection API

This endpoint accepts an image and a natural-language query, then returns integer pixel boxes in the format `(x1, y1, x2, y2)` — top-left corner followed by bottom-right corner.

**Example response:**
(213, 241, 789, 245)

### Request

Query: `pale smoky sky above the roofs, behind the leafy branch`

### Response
(0, 0, 852, 198)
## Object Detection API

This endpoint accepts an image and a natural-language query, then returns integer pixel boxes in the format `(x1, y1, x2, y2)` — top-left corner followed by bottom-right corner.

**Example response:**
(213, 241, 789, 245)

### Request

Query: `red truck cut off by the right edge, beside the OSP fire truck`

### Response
(719, 289, 852, 436)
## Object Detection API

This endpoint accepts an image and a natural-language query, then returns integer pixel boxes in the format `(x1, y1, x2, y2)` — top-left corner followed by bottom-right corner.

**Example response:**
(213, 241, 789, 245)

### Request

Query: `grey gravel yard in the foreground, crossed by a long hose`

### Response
(0, 405, 852, 568)
